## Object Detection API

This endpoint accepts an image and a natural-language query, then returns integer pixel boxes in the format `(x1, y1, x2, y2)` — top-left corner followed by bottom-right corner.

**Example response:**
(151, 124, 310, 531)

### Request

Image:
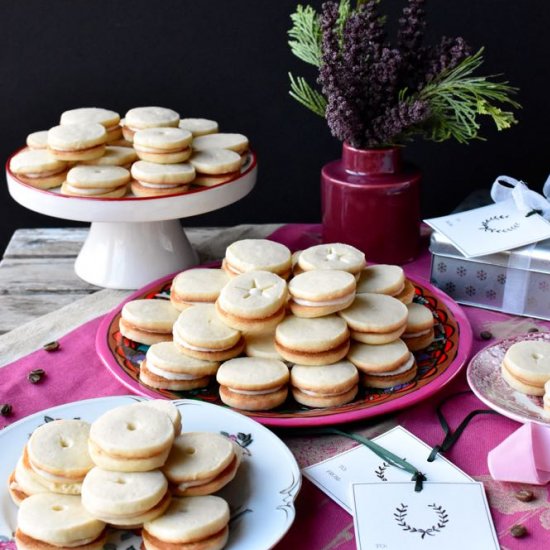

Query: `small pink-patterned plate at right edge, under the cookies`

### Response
(466, 332, 550, 426)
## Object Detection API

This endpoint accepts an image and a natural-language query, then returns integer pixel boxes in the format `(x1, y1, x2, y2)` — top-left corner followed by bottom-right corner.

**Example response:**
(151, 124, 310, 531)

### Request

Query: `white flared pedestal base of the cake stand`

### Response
(75, 220, 198, 289)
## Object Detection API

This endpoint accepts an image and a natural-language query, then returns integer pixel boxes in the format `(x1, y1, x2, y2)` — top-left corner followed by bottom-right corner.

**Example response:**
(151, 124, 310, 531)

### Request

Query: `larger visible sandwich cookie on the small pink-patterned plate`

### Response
(501, 340, 550, 396)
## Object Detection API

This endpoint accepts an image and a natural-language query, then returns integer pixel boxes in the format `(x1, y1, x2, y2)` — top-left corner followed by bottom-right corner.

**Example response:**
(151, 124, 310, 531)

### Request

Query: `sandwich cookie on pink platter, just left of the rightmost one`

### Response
(338, 294, 408, 344)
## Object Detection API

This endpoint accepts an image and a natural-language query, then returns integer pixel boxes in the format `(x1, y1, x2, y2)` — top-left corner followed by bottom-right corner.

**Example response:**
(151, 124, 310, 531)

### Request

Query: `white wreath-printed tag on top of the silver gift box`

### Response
(424, 199, 550, 258)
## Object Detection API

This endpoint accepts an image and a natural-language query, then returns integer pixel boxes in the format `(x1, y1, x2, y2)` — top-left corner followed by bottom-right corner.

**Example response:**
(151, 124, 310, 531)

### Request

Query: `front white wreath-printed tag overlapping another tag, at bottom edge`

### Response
(352, 482, 500, 550)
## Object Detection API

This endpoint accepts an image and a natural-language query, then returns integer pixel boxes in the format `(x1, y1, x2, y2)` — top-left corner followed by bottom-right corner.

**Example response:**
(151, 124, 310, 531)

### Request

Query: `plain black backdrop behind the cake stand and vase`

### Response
(0, 0, 550, 250)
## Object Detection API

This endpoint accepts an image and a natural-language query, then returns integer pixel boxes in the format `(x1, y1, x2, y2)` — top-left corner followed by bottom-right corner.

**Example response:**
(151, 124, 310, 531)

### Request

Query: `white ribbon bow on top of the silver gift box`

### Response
(491, 175, 550, 220)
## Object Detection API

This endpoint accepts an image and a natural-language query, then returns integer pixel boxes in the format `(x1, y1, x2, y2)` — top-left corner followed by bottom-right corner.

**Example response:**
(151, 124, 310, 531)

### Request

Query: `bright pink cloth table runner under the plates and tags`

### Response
(0, 224, 550, 550)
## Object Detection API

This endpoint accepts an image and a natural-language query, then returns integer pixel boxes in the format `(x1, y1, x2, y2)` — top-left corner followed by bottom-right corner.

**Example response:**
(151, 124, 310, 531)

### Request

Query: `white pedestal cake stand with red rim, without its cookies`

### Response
(6, 153, 258, 289)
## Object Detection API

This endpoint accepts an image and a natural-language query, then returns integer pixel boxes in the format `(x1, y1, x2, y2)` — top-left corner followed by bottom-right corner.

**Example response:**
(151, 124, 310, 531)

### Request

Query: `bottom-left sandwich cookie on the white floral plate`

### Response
(15, 493, 106, 550)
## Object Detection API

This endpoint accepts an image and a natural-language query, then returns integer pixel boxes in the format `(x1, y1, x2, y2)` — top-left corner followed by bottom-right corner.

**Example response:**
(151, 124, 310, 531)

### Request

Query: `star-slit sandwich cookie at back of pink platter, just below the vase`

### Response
(298, 243, 366, 276)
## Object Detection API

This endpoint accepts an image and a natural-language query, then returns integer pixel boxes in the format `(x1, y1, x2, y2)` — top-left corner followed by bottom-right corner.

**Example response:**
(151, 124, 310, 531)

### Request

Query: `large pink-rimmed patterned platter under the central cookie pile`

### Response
(96, 270, 473, 428)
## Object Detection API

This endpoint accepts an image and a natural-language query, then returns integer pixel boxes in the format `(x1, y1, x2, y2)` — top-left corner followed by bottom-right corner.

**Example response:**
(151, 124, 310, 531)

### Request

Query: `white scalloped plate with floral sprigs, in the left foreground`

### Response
(0, 395, 301, 550)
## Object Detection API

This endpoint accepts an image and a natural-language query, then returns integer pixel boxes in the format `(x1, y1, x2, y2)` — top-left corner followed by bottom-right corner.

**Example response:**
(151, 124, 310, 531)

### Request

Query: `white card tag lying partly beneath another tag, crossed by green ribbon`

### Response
(302, 426, 473, 514)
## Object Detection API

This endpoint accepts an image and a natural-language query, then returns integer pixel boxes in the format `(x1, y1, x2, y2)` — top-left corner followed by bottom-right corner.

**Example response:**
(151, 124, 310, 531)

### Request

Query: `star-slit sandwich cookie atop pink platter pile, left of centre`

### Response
(216, 271, 287, 334)
